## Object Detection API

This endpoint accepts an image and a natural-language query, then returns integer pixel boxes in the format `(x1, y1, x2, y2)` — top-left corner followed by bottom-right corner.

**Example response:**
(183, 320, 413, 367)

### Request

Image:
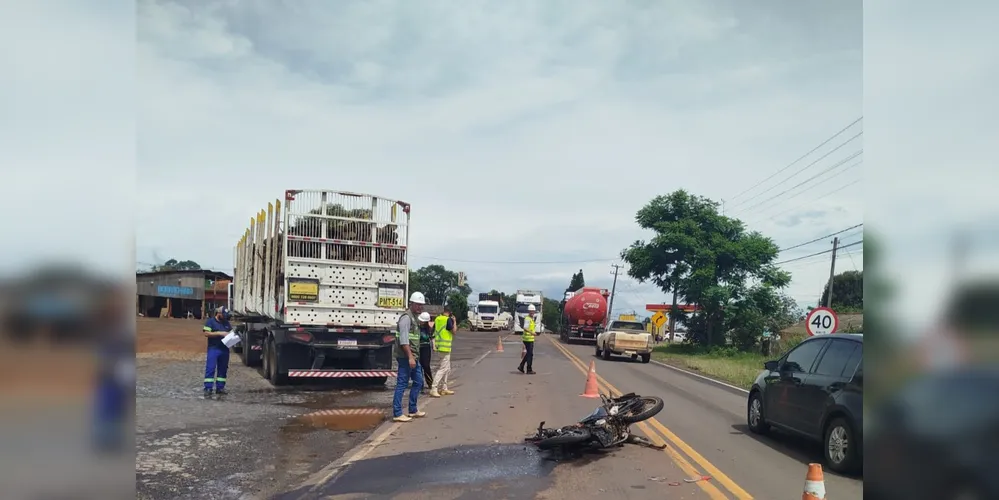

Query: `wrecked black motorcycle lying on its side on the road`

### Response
(525, 392, 664, 451)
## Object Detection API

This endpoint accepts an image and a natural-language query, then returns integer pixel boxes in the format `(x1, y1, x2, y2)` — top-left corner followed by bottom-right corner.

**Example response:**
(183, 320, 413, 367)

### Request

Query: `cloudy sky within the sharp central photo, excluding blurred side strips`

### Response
(136, 0, 863, 318)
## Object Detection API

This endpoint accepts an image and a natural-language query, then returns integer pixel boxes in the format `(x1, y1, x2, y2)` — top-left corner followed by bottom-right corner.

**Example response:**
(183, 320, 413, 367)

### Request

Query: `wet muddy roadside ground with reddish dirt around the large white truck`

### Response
(135, 318, 496, 500)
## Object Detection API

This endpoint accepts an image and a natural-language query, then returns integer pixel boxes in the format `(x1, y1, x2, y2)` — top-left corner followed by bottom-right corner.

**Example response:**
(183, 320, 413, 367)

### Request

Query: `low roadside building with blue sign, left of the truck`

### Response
(135, 269, 232, 319)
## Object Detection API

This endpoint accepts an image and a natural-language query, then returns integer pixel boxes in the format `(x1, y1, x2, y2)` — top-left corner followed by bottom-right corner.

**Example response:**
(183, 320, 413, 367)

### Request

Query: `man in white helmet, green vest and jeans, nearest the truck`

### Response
(392, 292, 427, 422)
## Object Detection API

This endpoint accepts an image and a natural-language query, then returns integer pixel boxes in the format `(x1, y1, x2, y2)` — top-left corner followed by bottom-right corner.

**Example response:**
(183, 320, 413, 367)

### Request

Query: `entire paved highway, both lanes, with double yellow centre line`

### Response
(279, 333, 862, 500)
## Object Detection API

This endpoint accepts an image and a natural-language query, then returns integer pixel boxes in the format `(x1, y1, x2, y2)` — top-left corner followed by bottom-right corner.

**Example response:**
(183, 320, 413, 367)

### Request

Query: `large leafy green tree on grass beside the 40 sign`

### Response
(621, 190, 791, 347)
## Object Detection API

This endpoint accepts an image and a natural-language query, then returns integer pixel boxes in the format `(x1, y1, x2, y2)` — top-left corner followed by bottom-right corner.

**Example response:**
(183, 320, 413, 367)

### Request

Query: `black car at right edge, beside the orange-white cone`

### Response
(747, 334, 864, 472)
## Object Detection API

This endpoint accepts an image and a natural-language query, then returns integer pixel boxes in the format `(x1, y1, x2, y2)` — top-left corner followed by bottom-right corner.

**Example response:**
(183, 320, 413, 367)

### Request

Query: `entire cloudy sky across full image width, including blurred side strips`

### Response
(13, 0, 999, 332)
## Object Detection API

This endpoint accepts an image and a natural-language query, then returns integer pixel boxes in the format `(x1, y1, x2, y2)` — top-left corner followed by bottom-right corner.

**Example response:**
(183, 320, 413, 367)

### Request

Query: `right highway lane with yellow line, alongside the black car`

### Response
(550, 339, 863, 499)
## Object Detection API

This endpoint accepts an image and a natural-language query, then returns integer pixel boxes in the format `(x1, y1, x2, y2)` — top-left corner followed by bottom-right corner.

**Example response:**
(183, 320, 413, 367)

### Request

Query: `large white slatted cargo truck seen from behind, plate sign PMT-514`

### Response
(232, 189, 410, 385)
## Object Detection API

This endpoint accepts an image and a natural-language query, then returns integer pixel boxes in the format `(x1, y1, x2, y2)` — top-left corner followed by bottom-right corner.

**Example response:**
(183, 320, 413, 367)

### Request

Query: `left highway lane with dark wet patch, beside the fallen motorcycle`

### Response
(275, 337, 708, 500)
